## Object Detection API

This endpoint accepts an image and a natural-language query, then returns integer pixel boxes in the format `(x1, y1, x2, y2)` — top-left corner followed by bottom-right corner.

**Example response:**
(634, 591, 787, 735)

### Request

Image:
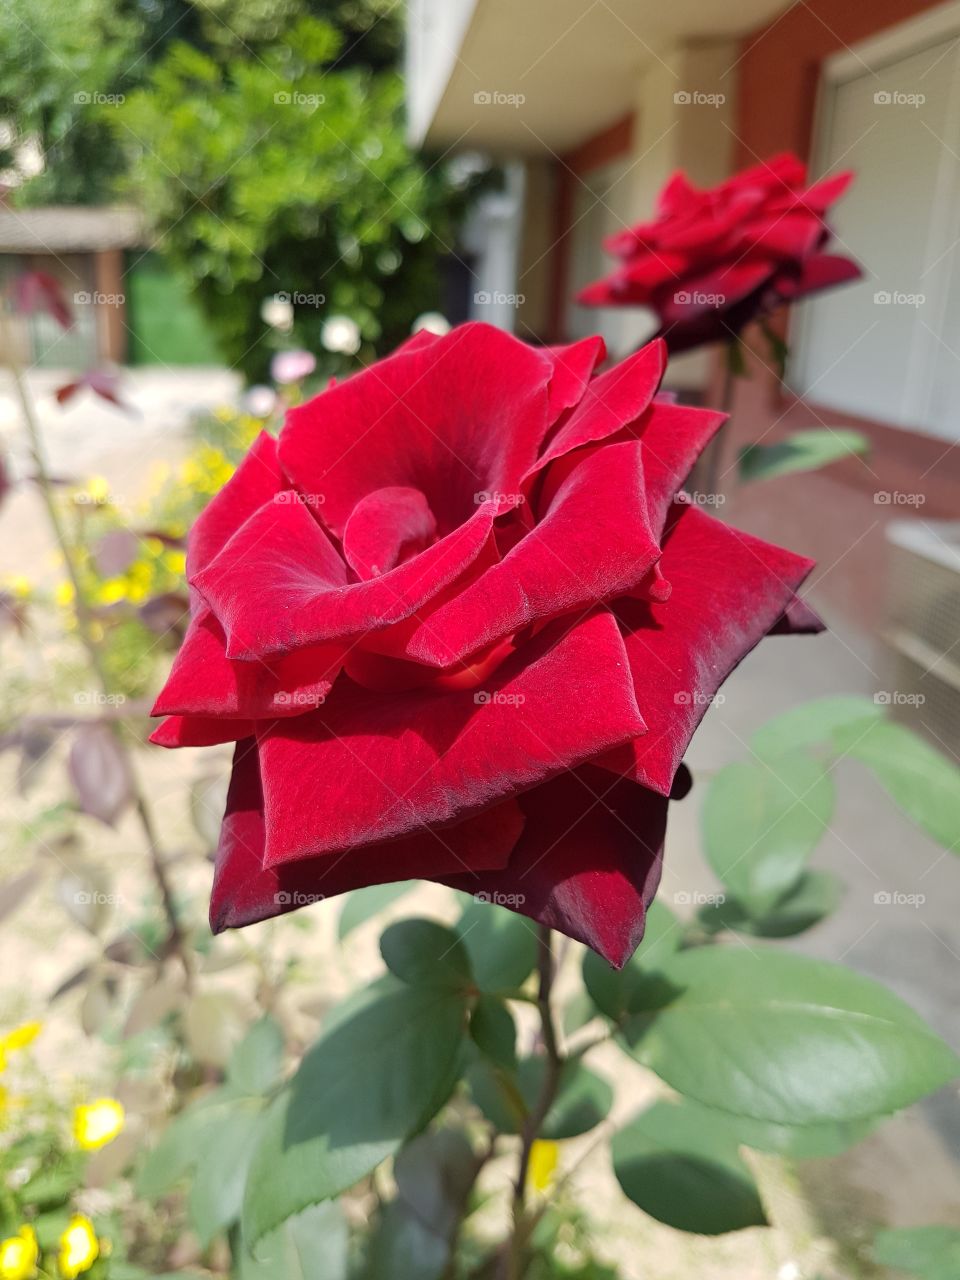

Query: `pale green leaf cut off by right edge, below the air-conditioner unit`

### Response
(835, 719, 960, 852)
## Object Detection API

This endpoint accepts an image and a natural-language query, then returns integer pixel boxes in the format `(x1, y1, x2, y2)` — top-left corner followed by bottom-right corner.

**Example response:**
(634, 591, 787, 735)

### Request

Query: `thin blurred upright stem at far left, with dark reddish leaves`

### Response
(9, 358, 193, 984)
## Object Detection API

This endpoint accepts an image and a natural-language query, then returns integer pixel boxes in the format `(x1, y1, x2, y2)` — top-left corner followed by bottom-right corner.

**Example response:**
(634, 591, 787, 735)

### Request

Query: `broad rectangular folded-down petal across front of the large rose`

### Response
(260, 611, 644, 865)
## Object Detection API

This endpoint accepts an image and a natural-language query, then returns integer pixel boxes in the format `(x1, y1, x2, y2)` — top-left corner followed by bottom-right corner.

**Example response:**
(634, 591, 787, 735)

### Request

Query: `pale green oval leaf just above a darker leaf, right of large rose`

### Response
(703, 750, 835, 914)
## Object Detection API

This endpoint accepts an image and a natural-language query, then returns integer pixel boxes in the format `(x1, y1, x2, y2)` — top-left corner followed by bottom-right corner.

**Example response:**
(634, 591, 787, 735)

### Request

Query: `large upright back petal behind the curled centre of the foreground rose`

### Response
(280, 324, 553, 538)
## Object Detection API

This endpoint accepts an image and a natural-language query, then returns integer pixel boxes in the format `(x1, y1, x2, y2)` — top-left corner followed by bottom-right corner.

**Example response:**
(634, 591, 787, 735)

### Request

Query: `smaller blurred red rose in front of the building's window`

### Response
(577, 155, 860, 352)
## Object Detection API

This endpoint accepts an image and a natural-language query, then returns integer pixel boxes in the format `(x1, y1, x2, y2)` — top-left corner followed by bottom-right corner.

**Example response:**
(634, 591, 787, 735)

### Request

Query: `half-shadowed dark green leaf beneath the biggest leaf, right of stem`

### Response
(612, 1101, 767, 1235)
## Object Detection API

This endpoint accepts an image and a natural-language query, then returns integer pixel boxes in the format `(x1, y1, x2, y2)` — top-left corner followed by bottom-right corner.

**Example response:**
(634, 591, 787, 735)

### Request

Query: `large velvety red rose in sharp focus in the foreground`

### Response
(154, 324, 814, 965)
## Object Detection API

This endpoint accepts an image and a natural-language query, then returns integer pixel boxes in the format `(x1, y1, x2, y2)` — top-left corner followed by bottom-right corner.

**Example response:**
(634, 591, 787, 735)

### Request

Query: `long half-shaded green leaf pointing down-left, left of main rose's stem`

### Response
(243, 977, 466, 1243)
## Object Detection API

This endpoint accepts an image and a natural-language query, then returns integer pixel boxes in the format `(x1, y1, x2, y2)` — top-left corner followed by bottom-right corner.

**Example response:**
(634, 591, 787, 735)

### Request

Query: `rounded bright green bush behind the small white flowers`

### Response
(111, 15, 481, 379)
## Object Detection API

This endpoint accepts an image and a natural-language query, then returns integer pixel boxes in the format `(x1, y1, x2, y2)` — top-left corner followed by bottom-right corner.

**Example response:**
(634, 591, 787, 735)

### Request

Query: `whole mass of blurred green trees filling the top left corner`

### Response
(0, 0, 476, 379)
